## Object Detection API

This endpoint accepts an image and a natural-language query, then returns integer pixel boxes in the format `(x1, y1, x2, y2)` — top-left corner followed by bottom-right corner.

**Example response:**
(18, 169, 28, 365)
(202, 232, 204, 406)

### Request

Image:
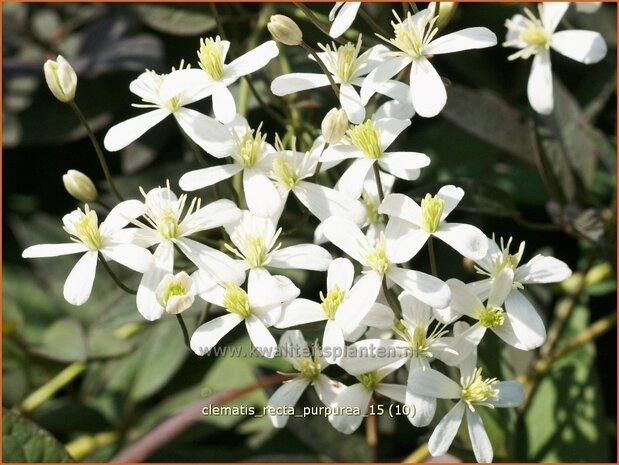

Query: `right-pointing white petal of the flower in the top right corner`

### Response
(550, 31, 607, 65)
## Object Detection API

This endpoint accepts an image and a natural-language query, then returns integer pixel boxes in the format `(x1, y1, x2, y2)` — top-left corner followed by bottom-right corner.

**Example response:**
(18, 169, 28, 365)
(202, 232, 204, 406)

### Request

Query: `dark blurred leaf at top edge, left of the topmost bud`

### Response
(133, 4, 215, 36)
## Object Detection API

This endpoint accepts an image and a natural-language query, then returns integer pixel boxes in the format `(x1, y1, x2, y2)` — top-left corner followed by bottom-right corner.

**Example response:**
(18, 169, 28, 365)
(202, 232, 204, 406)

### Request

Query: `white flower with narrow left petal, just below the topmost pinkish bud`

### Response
(271, 36, 388, 124)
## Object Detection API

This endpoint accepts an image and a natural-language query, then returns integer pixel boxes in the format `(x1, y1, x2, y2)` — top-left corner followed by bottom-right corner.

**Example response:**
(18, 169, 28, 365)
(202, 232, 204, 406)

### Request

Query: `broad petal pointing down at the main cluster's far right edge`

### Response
(505, 290, 546, 350)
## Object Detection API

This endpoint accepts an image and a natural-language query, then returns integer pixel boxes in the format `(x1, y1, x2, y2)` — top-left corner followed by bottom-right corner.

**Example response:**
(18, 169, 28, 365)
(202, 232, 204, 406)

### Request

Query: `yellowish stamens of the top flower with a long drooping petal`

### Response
(379, 11, 438, 59)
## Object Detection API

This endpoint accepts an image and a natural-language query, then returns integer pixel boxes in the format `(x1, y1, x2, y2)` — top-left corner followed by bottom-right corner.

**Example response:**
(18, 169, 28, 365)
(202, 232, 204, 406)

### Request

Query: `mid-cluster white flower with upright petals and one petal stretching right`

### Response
(226, 211, 332, 274)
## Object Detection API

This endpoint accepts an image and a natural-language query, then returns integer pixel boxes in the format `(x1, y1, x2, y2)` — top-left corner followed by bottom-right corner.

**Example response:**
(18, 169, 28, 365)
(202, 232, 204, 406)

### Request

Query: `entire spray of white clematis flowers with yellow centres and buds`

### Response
(23, 2, 606, 462)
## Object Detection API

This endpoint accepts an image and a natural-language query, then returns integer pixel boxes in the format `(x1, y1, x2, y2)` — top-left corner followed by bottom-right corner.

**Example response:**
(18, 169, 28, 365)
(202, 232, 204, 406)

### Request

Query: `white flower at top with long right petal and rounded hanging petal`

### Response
(361, 9, 497, 118)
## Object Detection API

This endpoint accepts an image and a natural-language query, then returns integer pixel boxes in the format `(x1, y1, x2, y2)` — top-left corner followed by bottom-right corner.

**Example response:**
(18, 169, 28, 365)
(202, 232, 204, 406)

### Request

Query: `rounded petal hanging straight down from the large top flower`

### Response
(410, 57, 447, 118)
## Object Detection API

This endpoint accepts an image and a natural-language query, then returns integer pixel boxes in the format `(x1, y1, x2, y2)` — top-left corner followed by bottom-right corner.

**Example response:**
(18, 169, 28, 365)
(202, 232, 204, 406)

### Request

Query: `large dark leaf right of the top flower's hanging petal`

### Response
(442, 84, 534, 165)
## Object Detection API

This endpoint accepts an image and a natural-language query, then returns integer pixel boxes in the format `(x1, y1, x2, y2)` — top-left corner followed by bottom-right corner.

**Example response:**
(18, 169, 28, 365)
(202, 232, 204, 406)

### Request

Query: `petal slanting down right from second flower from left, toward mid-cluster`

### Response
(176, 237, 245, 283)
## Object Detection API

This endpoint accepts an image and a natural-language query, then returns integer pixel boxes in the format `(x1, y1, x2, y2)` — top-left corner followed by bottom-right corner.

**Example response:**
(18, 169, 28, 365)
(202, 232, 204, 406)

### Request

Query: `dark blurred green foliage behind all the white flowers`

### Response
(2, 3, 616, 462)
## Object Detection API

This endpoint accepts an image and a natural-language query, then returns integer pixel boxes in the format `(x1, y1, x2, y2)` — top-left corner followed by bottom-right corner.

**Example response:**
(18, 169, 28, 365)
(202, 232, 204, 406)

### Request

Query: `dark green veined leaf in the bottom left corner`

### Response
(2, 408, 73, 463)
